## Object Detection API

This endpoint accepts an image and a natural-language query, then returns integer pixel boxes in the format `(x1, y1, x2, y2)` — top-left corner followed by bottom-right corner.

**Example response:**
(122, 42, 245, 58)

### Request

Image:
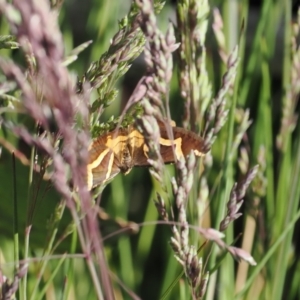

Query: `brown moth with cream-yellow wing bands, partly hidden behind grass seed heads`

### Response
(87, 124, 207, 189)
